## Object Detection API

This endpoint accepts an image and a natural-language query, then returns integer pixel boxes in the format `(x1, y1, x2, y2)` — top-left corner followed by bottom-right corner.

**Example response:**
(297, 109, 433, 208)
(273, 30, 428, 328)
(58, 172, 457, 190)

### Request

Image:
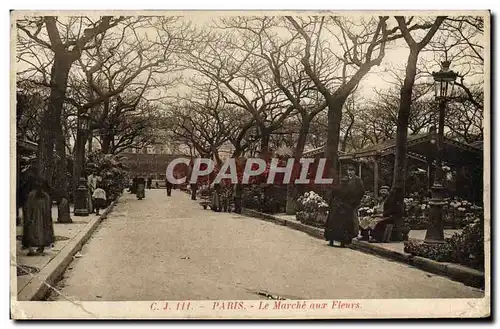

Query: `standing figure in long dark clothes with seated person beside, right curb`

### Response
(325, 165, 392, 247)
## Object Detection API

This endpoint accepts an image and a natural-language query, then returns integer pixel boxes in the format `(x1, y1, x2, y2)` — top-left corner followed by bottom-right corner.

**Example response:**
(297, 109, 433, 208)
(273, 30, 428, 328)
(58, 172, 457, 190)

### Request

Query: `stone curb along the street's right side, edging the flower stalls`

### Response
(242, 208, 485, 288)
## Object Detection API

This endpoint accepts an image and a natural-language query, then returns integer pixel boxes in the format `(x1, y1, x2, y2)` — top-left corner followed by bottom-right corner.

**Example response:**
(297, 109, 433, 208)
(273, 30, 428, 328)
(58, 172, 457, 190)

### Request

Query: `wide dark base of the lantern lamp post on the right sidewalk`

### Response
(424, 183, 447, 244)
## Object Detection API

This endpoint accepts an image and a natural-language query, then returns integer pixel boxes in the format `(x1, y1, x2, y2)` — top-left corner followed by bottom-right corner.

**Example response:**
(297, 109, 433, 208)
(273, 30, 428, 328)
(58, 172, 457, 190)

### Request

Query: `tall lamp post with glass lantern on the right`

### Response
(424, 60, 457, 244)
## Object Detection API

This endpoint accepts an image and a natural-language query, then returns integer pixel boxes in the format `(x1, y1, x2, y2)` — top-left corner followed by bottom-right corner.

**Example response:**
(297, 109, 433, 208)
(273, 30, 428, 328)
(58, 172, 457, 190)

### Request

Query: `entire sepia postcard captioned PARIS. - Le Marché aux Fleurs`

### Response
(10, 10, 491, 320)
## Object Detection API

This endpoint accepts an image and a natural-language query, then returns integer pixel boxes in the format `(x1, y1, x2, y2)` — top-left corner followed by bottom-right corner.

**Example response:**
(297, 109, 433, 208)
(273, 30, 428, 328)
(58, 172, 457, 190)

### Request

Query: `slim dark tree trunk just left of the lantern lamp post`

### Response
(386, 50, 418, 241)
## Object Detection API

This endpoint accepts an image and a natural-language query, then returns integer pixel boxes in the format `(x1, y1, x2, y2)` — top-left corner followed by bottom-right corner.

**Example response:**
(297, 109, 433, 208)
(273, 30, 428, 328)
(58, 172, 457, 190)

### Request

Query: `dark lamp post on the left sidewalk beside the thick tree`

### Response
(73, 113, 90, 216)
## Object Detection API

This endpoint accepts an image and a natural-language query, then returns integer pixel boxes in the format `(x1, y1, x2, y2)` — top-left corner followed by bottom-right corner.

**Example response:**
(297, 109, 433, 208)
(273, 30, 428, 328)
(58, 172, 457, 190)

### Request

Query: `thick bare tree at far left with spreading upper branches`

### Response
(16, 16, 124, 222)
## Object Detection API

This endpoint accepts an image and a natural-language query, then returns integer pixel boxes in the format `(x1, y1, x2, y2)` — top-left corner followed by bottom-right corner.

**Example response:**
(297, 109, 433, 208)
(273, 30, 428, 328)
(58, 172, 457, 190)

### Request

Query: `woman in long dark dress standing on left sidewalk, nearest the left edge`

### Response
(22, 178, 55, 256)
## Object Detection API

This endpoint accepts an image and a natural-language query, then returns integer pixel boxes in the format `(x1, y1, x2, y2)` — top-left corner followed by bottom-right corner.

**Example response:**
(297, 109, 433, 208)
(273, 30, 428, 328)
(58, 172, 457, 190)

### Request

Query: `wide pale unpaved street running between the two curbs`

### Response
(49, 189, 482, 301)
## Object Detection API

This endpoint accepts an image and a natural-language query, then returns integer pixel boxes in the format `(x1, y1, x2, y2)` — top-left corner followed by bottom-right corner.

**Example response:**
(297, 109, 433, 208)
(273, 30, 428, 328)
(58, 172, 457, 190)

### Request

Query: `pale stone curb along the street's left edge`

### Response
(17, 196, 120, 301)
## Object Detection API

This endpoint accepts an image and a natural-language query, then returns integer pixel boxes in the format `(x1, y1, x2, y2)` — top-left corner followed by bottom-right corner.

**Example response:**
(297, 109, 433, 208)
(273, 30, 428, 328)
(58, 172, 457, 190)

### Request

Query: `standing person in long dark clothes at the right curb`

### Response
(325, 165, 365, 247)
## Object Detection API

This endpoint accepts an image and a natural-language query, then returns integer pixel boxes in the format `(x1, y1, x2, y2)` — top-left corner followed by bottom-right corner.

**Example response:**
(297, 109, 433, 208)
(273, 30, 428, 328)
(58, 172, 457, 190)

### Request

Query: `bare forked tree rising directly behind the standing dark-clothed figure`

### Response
(287, 17, 390, 184)
